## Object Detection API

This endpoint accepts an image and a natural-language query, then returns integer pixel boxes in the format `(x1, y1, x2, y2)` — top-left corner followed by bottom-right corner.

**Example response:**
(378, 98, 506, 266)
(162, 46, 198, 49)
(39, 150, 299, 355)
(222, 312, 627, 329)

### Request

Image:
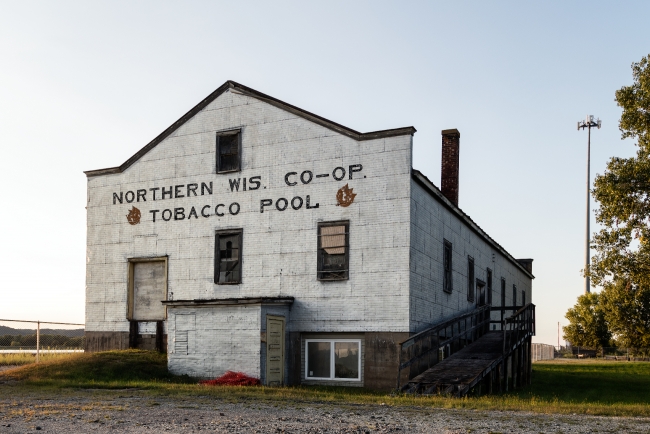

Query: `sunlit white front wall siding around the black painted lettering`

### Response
(86, 92, 411, 331)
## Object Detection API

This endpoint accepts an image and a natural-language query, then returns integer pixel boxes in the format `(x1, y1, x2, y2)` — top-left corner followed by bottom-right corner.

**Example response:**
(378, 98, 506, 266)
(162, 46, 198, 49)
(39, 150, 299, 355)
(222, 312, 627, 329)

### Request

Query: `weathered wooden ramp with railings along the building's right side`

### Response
(397, 303, 535, 396)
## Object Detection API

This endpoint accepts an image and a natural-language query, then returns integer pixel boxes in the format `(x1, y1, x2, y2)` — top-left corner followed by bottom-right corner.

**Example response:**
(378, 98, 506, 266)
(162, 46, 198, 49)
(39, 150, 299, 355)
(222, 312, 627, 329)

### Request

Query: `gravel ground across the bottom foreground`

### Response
(0, 392, 650, 433)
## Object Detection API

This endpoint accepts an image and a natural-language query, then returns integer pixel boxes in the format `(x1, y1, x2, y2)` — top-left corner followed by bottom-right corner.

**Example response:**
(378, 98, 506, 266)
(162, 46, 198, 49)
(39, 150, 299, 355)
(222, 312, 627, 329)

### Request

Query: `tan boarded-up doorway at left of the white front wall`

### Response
(129, 260, 167, 321)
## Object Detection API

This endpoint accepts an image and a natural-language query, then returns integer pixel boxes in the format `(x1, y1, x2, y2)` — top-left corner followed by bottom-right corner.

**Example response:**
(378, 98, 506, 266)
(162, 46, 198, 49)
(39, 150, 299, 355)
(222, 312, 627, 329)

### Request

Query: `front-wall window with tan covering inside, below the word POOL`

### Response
(317, 222, 350, 280)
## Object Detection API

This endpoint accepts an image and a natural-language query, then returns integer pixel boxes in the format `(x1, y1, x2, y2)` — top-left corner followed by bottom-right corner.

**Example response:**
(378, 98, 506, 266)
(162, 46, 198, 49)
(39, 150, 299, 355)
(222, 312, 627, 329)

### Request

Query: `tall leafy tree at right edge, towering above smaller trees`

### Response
(586, 55, 650, 288)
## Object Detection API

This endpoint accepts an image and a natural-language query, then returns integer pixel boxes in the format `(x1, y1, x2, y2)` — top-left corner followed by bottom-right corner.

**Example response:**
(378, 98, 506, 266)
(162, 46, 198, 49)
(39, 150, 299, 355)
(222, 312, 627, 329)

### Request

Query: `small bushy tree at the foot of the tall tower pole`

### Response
(562, 292, 612, 348)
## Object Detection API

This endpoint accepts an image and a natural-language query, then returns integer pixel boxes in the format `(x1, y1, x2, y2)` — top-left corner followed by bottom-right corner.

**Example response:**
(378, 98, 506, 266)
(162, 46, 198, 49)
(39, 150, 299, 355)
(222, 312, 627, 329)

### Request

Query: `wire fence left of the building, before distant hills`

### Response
(0, 319, 85, 362)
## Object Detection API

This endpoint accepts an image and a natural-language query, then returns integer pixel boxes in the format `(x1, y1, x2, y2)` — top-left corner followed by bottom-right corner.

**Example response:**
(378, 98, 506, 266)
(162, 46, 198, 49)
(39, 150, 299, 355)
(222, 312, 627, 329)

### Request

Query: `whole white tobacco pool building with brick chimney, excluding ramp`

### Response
(85, 81, 533, 388)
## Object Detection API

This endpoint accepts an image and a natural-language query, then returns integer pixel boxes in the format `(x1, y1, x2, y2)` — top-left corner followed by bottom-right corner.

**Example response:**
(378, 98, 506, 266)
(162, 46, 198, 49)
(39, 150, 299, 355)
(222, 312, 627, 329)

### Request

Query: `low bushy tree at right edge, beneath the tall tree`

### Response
(599, 280, 650, 348)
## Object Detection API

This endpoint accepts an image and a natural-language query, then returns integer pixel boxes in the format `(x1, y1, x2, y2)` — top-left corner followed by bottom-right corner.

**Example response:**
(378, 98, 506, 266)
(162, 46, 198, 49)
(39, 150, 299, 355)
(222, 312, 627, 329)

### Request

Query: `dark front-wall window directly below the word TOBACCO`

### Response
(214, 229, 242, 285)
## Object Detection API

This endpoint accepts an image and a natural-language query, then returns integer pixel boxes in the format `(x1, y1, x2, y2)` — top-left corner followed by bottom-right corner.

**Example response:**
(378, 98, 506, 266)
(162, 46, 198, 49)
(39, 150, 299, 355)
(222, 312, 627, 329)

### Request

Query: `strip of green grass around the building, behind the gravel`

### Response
(0, 350, 650, 417)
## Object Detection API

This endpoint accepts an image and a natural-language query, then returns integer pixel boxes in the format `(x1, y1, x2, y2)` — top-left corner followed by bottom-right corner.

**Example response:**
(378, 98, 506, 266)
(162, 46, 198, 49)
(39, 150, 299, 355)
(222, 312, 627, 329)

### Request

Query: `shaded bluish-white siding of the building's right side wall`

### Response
(410, 181, 532, 332)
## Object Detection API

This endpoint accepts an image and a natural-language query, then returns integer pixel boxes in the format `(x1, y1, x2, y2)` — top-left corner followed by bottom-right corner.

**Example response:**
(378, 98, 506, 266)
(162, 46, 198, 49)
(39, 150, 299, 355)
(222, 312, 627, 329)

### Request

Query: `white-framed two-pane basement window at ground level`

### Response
(305, 339, 361, 381)
